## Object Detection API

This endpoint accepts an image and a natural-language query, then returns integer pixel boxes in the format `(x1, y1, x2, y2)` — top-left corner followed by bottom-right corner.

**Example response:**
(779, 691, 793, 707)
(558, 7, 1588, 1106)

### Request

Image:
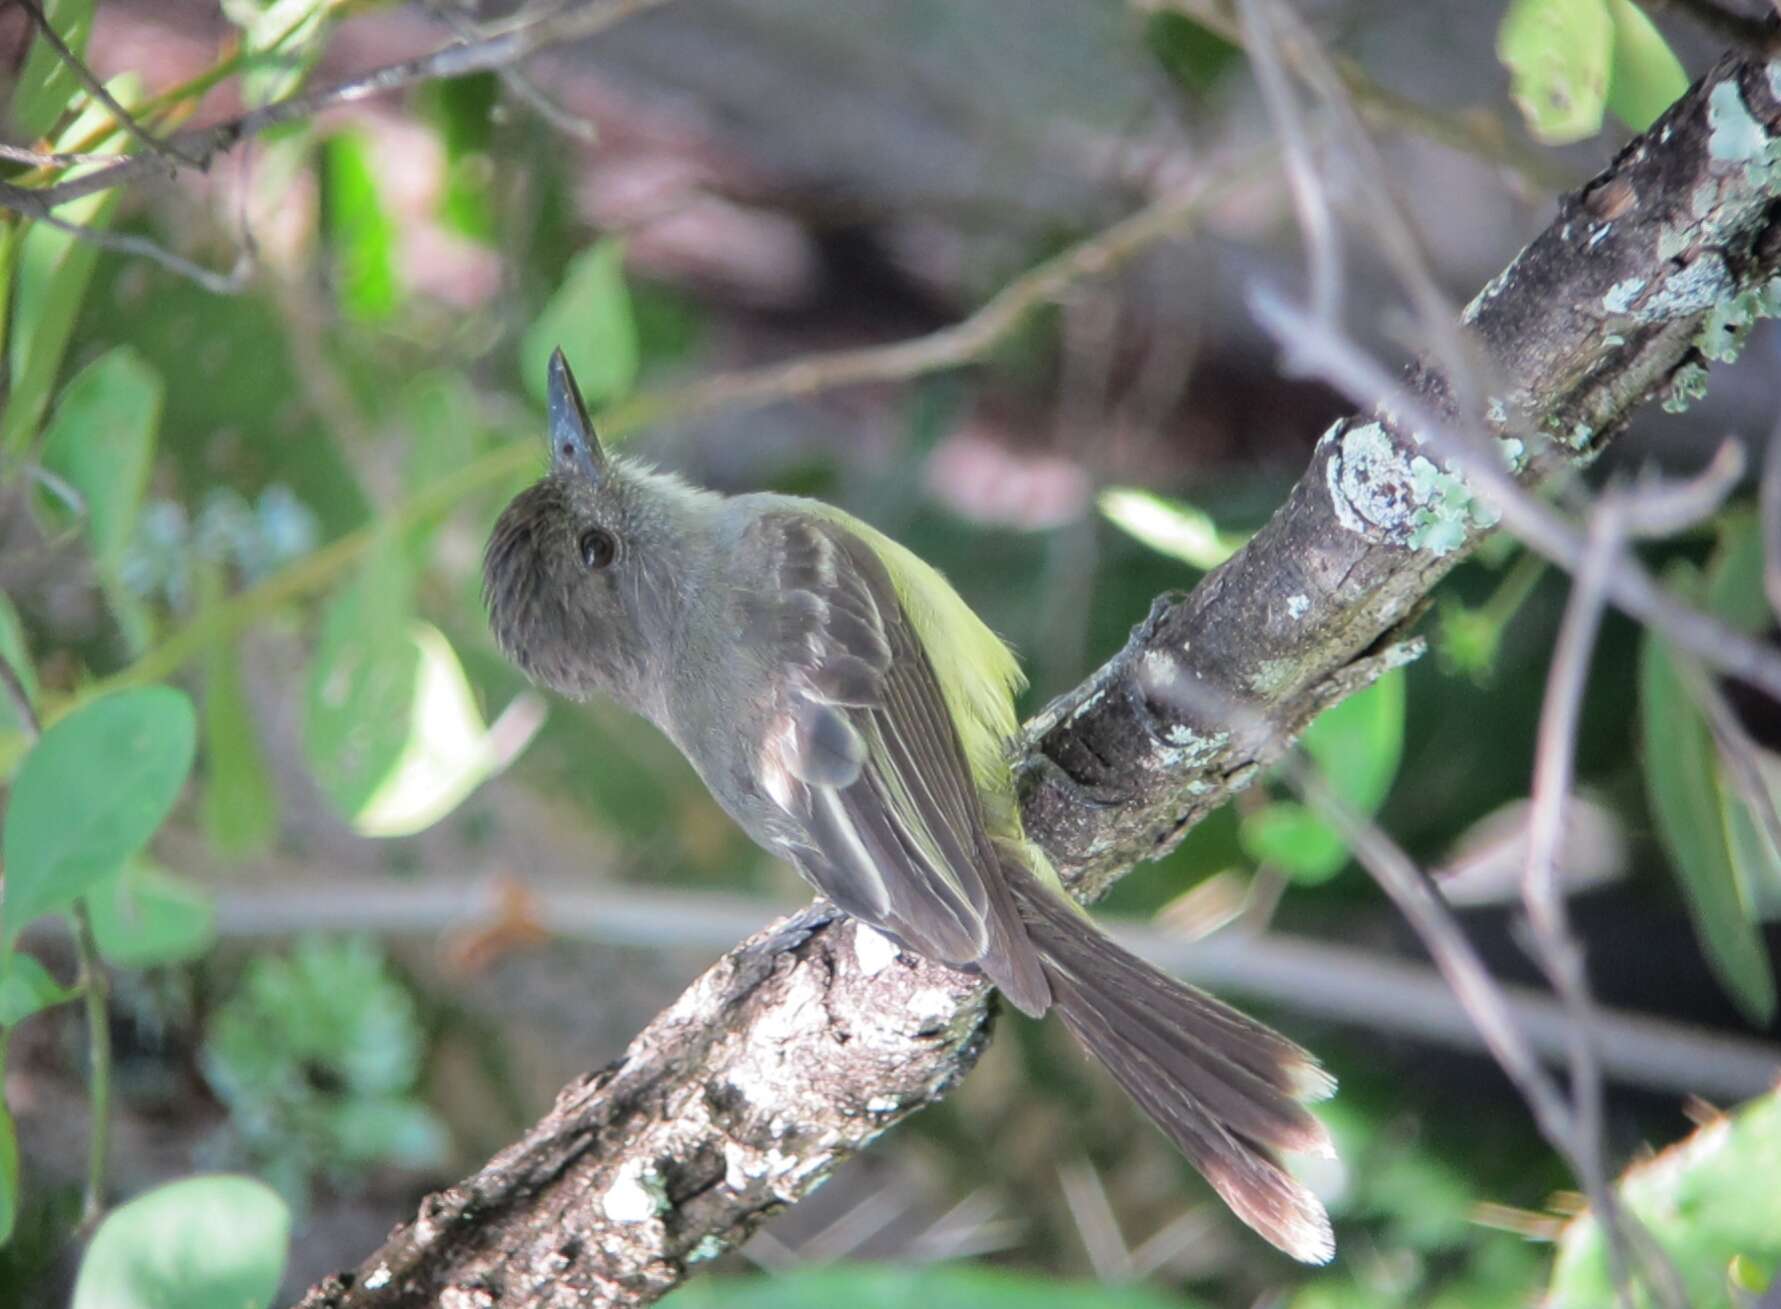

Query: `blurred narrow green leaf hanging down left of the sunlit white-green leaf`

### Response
(199, 568, 278, 857)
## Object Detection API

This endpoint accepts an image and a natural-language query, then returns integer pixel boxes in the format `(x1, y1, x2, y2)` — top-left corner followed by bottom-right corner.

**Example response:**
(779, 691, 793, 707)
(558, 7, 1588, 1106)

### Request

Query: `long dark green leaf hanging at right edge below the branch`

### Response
(1639, 623, 1776, 1026)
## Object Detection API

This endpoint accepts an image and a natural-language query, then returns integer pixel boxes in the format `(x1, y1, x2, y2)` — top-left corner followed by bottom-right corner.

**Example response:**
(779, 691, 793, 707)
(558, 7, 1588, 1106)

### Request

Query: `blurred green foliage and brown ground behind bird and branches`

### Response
(0, 0, 1781, 1309)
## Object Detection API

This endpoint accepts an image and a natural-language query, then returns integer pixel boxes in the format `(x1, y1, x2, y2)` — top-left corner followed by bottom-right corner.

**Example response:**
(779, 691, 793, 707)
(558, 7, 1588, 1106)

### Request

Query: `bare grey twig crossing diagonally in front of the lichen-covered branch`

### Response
(1250, 289, 1781, 698)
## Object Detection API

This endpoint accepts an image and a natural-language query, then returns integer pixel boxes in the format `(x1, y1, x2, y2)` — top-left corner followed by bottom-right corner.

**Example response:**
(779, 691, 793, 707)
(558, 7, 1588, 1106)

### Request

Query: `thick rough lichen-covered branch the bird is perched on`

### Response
(288, 59, 1781, 1309)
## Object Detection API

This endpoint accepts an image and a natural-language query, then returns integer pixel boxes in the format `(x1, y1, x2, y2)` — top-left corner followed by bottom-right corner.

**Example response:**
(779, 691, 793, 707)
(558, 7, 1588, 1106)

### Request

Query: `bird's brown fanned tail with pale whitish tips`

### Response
(1004, 857, 1336, 1263)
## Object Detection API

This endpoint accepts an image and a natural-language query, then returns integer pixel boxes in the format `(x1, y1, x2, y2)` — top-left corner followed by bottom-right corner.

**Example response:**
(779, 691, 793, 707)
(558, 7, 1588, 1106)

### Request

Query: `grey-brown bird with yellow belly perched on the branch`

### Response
(483, 349, 1336, 1263)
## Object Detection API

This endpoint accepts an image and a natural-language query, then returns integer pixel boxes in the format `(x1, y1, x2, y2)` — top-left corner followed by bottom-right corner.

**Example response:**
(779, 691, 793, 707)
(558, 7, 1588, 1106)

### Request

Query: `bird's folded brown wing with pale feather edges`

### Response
(739, 511, 1049, 1012)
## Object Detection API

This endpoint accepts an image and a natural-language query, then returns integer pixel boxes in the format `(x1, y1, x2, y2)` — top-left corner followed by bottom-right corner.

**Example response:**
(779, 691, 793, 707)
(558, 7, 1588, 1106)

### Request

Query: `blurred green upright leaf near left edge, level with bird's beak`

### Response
(39, 346, 164, 579)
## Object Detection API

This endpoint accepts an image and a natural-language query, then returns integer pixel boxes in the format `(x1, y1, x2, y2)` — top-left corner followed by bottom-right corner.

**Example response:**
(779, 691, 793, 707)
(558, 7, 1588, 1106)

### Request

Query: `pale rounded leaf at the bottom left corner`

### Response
(71, 1175, 290, 1309)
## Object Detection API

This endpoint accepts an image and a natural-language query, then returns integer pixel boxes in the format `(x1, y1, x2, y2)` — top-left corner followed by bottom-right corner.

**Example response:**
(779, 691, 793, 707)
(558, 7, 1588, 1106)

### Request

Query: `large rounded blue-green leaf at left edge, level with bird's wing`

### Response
(0, 686, 198, 940)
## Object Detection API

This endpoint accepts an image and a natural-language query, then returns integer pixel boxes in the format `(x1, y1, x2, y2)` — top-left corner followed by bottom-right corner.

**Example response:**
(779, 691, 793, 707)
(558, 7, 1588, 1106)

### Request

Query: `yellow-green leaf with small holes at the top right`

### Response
(1496, 0, 1614, 146)
